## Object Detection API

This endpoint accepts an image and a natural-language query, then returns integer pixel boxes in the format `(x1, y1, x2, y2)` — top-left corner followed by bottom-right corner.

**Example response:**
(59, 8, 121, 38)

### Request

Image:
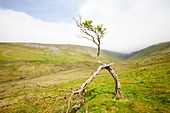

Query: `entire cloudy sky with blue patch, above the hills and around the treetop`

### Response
(0, 0, 170, 53)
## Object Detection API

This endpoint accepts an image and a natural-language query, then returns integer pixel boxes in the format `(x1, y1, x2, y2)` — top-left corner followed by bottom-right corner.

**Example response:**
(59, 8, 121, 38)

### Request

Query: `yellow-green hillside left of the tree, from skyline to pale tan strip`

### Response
(0, 43, 117, 83)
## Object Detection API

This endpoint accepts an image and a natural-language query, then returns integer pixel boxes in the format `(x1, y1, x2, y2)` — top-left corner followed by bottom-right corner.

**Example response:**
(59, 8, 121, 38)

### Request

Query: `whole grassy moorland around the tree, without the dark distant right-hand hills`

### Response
(0, 43, 170, 113)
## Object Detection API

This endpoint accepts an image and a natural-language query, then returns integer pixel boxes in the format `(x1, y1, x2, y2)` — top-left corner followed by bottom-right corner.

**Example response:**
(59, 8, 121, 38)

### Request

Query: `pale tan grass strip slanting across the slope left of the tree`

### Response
(0, 68, 92, 95)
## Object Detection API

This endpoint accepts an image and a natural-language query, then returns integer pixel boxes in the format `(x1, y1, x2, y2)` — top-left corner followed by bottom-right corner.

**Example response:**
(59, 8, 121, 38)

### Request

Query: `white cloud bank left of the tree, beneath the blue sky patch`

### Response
(0, 9, 91, 44)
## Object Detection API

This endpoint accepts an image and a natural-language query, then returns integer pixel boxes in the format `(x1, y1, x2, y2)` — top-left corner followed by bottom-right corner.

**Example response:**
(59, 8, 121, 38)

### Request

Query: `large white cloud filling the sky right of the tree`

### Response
(80, 0, 170, 52)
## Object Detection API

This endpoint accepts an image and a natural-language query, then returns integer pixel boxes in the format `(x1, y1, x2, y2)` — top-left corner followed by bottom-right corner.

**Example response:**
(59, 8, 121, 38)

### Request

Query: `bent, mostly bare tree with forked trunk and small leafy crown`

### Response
(66, 16, 124, 113)
